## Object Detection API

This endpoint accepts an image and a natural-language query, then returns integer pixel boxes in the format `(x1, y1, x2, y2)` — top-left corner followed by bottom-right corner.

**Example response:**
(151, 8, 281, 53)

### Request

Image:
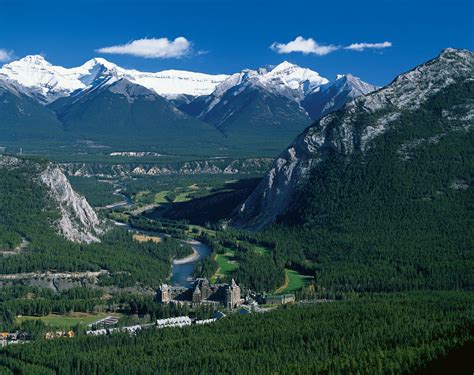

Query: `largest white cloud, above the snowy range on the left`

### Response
(97, 36, 192, 59)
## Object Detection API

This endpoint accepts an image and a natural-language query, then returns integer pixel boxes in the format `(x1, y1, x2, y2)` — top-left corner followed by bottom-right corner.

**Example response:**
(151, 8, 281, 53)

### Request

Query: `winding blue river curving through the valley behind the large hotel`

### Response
(114, 221, 212, 286)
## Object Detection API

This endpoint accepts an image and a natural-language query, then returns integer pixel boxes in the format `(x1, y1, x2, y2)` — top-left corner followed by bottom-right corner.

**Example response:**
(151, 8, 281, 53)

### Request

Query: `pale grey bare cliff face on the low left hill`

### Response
(40, 164, 104, 243)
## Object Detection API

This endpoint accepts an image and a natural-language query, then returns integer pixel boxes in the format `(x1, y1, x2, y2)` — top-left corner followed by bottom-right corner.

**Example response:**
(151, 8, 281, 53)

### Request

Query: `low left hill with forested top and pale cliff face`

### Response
(0, 156, 104, 245)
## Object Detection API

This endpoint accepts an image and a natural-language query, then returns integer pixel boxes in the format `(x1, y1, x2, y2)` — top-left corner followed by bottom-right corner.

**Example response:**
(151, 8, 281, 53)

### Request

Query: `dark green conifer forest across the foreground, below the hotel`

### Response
(0, 292, 474, 374)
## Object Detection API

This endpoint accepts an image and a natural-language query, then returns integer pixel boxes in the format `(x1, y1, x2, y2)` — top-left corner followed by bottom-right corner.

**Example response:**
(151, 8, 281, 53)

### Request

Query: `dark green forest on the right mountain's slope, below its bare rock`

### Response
(231, 82, 474, 296)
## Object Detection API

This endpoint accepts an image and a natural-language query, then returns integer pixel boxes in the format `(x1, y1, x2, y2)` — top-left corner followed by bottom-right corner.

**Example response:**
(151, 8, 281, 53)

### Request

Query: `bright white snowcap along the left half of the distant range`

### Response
(0, 55, 228, 103)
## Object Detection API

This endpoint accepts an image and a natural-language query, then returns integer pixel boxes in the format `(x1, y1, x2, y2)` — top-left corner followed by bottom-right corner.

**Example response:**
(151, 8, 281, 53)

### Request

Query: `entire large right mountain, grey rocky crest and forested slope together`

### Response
(231, 49, 474, 292)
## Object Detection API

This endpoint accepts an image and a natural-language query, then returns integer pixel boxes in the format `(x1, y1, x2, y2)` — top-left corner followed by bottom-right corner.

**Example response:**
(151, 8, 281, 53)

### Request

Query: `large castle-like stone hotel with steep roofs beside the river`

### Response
(158, 278, 242, 309)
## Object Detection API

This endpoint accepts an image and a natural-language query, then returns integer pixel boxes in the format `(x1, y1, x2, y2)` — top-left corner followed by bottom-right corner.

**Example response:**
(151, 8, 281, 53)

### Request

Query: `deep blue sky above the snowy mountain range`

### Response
(0, 0, 474, 85)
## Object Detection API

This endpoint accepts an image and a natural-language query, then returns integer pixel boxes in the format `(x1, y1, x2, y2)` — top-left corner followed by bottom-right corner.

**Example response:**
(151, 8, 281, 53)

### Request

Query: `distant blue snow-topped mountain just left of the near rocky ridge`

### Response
(179, 62, 328, 148)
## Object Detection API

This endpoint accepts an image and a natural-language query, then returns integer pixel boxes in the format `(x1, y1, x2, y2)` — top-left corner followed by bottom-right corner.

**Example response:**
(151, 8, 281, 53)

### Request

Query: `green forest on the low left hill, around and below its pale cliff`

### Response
(0, 157, 191, 287)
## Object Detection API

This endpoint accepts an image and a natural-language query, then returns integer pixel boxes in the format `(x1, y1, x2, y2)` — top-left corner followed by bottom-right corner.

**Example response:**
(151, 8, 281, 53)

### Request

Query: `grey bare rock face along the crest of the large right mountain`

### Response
(234, 48, 474, 229)
